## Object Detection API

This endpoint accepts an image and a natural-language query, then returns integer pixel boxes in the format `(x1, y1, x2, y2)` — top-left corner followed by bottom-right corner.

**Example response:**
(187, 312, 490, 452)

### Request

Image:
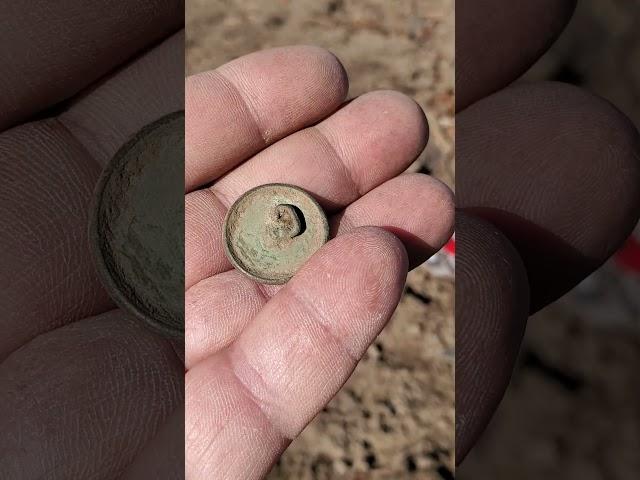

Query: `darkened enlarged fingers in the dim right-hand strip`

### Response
(456, 0, 640, 463)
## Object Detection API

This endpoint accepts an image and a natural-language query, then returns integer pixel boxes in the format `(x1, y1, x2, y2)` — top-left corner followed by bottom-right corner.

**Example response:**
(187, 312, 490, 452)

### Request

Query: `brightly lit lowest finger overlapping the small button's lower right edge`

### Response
(185, 228, 407, 479)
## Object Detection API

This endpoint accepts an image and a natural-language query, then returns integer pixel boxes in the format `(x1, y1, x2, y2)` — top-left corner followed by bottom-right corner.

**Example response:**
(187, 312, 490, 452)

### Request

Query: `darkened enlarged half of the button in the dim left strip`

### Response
(89, 112, 184, 338)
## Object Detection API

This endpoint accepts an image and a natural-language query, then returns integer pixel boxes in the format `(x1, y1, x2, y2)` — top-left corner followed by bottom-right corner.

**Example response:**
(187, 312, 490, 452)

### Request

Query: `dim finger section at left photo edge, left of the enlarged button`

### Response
(0, 119, 113, 361)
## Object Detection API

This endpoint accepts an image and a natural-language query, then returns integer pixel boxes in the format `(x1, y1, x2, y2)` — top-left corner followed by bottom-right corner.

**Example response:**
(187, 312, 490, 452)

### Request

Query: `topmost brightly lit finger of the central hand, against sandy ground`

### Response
(185, 46, 348, 192)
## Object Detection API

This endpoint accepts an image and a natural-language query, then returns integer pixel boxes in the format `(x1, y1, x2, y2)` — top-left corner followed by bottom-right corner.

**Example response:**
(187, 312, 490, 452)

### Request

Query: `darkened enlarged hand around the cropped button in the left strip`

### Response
(0, 0, 184, 479)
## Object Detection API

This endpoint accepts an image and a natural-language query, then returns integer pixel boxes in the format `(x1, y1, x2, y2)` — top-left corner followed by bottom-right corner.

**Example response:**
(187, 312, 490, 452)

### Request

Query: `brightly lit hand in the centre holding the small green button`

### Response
(185, 47, 453, 479)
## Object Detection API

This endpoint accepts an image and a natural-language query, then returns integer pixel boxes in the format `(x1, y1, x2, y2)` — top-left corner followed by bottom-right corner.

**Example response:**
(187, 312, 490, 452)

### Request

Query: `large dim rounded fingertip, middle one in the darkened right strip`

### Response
(456, 83, 640, 312)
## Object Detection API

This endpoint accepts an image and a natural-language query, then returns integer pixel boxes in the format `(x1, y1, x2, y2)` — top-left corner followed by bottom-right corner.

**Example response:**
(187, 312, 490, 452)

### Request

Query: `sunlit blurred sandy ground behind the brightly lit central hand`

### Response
(186, 0, 455, 480)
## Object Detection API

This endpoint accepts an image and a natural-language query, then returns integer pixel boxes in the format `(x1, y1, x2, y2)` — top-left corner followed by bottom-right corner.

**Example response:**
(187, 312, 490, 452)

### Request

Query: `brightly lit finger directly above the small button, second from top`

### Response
(211, 91, 429, 210)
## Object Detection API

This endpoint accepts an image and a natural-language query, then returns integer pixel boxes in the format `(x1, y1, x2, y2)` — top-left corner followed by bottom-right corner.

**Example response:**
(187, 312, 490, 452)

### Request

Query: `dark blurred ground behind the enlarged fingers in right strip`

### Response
(457, 0, 640, 480)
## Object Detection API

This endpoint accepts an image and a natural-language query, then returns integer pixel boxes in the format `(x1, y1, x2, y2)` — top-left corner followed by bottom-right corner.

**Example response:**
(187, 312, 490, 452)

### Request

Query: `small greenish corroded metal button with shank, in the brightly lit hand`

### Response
(223, 183, 329, 285)
